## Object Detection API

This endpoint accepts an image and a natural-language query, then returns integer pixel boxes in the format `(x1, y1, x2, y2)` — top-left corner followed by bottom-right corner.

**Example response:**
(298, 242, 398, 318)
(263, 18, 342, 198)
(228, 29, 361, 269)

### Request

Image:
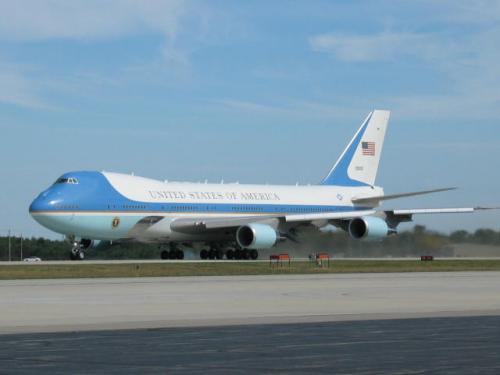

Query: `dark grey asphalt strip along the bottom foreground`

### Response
(0, 317, 500, 375)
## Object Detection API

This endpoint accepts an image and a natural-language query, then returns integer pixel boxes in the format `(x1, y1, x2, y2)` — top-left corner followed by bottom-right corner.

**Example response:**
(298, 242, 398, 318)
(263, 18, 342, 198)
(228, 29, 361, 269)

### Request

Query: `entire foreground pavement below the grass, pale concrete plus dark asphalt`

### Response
(0, 272, 500, 374)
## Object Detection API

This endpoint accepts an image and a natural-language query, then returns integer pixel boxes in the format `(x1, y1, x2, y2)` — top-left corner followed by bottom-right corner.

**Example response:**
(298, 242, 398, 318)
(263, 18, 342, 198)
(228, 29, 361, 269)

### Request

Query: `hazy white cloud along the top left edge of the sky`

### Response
(0, 0, 186, 41)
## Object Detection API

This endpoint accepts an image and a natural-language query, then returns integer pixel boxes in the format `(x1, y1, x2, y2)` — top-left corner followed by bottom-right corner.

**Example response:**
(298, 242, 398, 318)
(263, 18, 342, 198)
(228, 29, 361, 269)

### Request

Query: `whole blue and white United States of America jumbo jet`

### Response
(29, 110, 488, 260)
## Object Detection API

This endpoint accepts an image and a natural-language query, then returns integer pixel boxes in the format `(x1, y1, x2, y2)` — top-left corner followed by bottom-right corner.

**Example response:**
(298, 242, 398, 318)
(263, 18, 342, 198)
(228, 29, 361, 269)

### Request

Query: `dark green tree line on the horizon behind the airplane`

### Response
(0, 225, 500, 261)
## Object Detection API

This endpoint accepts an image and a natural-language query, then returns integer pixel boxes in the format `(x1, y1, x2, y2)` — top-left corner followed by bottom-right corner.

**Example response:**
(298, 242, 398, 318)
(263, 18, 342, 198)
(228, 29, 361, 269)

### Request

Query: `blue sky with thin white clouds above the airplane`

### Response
(0, 0, 500, 237)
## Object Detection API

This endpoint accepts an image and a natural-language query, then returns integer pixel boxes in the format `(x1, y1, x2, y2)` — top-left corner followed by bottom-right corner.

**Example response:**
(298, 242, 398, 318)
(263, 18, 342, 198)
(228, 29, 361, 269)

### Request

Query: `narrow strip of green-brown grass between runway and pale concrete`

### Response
(0, 260, 500, 280)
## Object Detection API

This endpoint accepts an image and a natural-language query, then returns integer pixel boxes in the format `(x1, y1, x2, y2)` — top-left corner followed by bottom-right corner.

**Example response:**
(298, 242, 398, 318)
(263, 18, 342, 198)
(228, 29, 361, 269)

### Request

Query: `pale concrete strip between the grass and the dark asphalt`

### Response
(0, 272, 500, 333)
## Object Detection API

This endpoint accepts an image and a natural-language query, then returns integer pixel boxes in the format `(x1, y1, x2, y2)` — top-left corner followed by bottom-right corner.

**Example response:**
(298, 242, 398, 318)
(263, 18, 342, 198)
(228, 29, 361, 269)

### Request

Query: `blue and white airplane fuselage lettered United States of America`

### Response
(30, 171, 383, 241)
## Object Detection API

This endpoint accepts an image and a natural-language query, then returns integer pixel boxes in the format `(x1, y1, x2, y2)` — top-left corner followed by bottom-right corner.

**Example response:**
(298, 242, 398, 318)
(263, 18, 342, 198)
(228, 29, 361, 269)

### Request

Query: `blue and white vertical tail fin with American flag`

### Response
(321, 110, 390, 186)
